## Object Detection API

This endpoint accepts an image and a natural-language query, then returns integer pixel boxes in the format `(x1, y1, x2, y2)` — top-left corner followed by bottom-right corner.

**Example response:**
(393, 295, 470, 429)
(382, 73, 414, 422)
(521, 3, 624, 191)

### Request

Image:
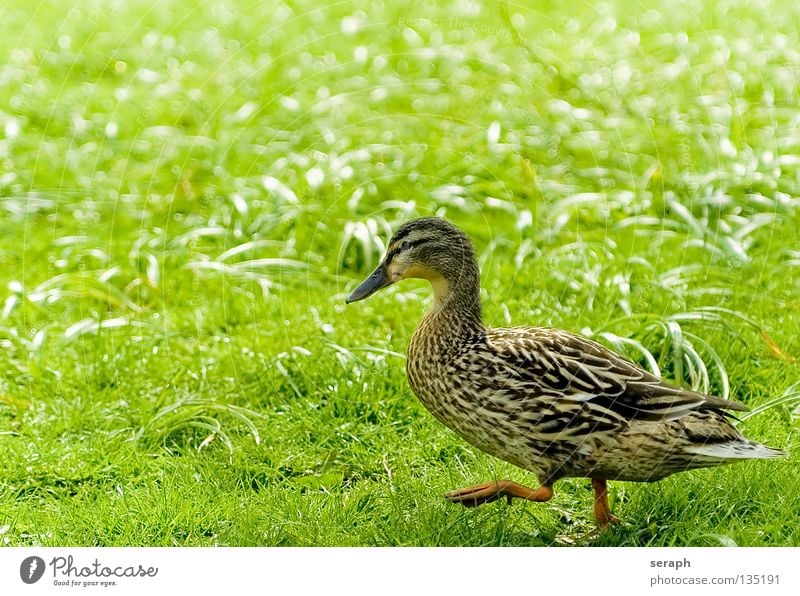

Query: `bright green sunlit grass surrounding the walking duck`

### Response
(0, 0, 800, 546)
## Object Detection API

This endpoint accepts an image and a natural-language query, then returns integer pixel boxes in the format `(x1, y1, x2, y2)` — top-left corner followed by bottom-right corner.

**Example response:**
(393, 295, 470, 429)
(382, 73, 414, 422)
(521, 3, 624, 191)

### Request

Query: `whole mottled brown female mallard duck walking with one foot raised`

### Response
(347, 217, 783, 527)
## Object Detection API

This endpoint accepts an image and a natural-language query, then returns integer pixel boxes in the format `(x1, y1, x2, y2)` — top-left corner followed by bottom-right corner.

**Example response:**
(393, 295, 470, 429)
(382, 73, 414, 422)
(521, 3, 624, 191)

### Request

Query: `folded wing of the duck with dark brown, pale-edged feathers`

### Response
(486, 327, 747, 422)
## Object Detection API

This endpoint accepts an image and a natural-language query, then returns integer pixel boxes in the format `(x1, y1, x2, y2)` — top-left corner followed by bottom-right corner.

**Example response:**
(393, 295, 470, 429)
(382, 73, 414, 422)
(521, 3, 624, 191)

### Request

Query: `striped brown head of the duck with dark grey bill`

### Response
(347, 217, 479, 306)
